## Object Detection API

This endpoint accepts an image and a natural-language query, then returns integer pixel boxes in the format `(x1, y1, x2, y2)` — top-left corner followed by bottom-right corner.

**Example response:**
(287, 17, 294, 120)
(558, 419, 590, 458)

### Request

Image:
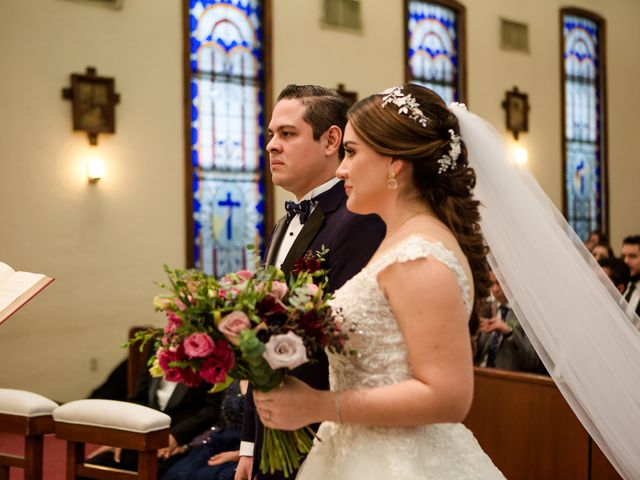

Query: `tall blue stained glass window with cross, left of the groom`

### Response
(189, 0, 265, 275)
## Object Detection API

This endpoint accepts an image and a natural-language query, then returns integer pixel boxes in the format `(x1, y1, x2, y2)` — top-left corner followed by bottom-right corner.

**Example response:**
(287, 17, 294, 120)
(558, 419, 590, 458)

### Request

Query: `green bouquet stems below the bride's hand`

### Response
(260, 427, 315, 478)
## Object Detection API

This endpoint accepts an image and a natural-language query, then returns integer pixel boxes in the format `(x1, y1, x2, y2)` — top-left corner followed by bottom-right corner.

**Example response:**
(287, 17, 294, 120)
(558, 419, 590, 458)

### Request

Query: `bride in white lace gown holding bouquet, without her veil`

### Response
(255, 85, 503, 480)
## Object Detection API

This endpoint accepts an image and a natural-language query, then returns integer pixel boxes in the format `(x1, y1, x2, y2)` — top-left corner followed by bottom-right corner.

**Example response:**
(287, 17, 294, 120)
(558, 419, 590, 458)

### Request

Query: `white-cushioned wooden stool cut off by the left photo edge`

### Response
(0, 388, 58, 480)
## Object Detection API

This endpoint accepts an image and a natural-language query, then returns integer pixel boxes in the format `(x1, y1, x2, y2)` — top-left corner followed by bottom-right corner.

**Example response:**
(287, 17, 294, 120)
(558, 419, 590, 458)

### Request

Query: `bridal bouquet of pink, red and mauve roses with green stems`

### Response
(133, 250, 347, 477)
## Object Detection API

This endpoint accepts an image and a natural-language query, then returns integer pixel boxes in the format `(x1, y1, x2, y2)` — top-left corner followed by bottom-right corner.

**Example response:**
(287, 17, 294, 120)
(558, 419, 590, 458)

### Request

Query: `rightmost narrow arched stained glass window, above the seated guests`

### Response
(561, 9, 607, 244)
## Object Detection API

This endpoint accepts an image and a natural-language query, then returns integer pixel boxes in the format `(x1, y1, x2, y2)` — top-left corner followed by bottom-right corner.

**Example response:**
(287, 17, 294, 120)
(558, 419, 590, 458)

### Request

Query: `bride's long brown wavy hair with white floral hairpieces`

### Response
(347, 84, 491, 331)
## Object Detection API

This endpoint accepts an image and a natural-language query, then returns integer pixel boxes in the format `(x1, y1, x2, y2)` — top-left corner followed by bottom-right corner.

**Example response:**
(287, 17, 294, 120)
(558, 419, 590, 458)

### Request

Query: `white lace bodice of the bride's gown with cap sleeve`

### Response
(329, 235, 472, 390)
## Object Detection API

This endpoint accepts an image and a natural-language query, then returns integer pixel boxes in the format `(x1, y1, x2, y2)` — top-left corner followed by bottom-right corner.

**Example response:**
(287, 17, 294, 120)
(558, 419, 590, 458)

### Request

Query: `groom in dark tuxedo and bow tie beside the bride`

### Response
(235, 85, 385, 480)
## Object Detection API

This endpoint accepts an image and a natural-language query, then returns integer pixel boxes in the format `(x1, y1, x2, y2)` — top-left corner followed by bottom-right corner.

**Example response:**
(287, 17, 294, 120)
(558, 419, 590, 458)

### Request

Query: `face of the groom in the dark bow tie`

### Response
(267, 99, 328, 199)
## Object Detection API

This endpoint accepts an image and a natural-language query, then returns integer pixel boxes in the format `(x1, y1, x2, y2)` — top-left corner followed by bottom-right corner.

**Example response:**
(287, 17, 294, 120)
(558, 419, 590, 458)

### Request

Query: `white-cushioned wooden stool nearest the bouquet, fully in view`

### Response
(53, 399, 171, 480)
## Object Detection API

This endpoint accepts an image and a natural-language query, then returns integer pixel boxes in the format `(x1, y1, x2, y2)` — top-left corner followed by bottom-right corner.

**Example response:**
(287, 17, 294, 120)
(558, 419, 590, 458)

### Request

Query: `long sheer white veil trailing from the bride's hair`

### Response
(449, 103, 640, 480)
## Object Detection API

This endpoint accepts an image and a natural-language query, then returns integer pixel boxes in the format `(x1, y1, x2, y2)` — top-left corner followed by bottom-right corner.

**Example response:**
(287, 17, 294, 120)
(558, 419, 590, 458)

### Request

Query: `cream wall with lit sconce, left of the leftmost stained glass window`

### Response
(0, 0, 185, 401)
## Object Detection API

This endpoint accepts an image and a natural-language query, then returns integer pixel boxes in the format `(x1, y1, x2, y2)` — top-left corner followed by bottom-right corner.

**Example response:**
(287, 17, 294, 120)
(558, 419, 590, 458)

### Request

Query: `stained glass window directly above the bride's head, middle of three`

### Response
(406, 0, 466, 104)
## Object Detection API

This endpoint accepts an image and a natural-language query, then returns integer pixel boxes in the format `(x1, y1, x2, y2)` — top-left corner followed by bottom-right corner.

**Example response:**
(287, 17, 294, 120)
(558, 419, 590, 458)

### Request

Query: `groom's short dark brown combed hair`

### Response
(278, 84, 349, 160)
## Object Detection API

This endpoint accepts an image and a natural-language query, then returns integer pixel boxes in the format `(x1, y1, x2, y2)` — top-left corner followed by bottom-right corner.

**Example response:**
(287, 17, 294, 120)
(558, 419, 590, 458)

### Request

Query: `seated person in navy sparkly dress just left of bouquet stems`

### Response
(162, 380, 247, 480)
